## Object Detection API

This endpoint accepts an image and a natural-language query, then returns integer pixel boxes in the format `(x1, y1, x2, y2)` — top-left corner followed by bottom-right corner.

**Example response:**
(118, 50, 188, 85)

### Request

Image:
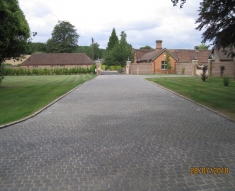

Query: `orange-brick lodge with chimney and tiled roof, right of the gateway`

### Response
(131, 40, 211, 74)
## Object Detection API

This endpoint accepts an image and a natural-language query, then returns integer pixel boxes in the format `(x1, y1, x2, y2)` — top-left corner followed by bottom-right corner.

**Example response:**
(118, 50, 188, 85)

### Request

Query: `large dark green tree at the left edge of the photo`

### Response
(0, 0, 30, 84)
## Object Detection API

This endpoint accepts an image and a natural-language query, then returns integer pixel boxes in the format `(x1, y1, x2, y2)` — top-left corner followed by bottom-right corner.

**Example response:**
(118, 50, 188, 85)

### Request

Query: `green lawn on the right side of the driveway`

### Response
(148, 77, 235, 120)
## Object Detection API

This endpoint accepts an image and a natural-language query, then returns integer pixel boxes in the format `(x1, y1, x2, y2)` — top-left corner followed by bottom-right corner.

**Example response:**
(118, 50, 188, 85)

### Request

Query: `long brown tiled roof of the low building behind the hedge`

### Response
(21, 53, 92, 66)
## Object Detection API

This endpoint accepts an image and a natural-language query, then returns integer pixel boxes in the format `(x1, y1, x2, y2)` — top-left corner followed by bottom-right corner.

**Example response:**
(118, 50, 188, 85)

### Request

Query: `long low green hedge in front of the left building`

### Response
(3, 66, 95, 76)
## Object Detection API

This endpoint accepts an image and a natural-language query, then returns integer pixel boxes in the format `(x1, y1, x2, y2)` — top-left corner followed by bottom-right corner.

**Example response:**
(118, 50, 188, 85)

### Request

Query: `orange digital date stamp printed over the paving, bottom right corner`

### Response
(190, 167, 229, 174)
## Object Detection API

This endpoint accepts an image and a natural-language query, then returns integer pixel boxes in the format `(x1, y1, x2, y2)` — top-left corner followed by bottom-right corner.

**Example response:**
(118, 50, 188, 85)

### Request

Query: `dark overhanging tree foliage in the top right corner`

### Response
(171, 0, 235, 57)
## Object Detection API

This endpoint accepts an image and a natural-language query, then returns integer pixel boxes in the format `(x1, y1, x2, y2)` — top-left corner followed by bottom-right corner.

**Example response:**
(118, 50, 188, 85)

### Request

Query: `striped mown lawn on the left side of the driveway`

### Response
(0, 74, 95, 125)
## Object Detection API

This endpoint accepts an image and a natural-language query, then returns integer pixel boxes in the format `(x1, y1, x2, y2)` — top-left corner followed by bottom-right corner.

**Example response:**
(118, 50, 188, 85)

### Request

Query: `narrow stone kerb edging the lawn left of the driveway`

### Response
(0, 76, 97, 129)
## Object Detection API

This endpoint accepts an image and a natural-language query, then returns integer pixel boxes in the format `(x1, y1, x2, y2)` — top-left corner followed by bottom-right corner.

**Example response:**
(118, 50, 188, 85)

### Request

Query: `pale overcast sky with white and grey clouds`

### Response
(19, 0, 206, 49)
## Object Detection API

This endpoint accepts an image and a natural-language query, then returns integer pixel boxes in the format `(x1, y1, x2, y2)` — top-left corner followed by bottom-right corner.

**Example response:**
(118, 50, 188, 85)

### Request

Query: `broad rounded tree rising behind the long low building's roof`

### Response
(47, 21, 79, 53)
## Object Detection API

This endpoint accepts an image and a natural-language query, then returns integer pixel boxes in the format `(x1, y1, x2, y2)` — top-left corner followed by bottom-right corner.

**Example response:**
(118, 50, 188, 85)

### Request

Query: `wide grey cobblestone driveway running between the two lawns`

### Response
(0, 75, 235, 191)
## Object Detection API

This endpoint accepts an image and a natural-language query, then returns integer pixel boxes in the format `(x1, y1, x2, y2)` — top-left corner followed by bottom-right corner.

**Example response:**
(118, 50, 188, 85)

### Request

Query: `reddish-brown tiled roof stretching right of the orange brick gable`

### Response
(169, 49, 211, 63)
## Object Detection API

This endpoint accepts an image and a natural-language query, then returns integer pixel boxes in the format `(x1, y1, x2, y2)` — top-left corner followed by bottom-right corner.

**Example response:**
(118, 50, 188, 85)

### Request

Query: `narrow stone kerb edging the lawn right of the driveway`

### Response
(144, 79, 235, 122)
